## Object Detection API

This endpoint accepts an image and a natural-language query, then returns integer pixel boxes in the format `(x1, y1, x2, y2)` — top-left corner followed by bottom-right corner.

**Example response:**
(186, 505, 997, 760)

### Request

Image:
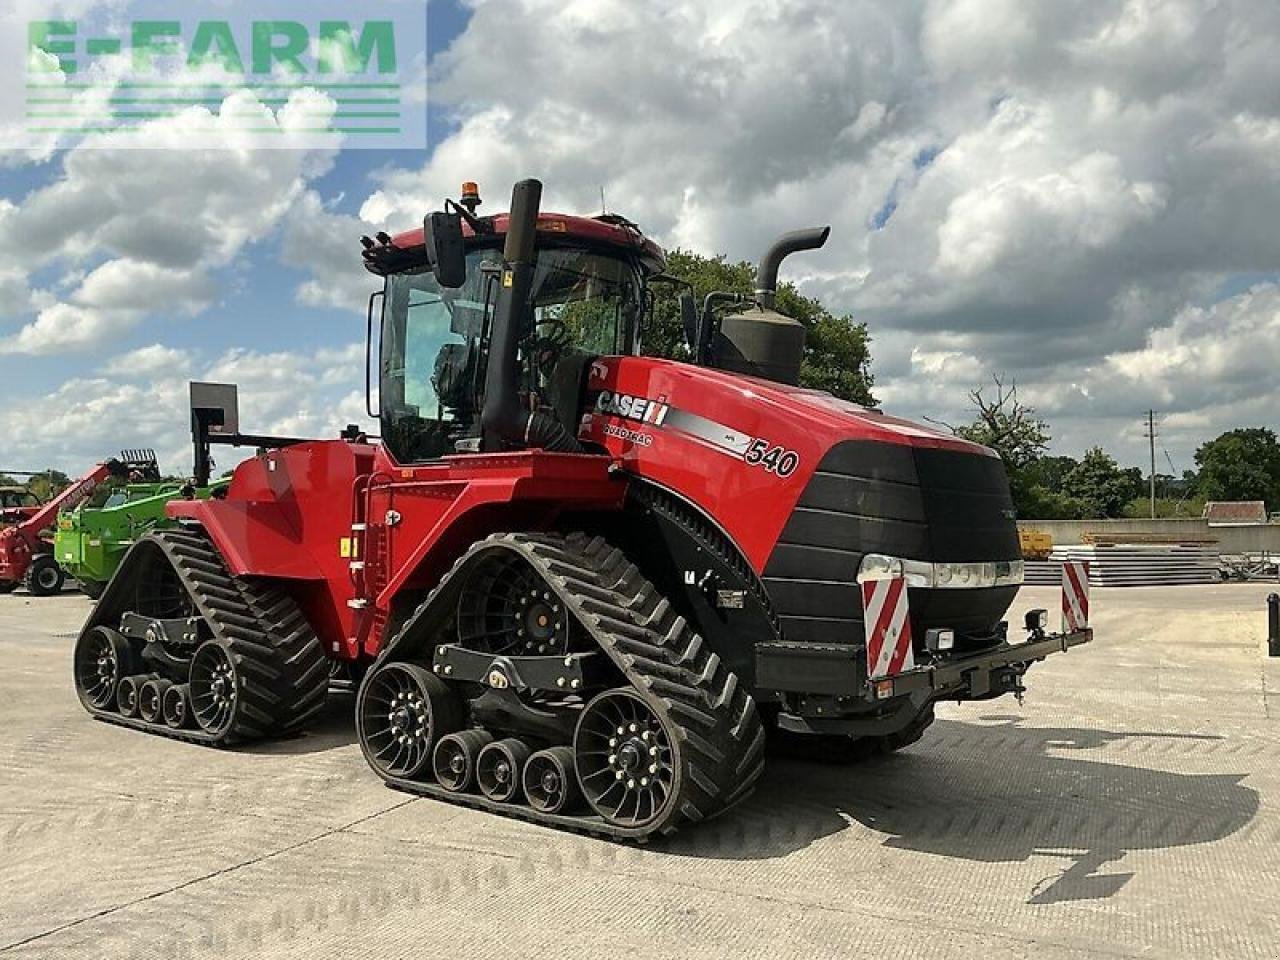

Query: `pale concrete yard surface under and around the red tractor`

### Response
(0, 585, 1280, 960)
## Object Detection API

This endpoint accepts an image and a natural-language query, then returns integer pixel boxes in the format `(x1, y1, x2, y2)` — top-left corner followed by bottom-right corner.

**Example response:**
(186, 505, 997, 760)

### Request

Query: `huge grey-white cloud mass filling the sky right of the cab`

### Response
(327, 0, 1280, 468)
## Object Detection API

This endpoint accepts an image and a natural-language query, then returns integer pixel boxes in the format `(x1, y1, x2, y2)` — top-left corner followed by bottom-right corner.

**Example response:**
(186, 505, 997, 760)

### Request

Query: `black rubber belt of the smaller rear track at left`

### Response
(77, 529, 329, 746)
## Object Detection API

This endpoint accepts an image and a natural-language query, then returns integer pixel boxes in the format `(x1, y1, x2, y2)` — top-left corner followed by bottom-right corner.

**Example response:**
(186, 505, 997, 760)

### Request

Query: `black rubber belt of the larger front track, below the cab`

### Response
(370, 534, 764, 840)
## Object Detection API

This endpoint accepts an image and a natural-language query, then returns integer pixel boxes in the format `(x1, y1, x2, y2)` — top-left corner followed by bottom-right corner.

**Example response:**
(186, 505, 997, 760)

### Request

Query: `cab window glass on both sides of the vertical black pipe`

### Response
(379, 248, 643, 463)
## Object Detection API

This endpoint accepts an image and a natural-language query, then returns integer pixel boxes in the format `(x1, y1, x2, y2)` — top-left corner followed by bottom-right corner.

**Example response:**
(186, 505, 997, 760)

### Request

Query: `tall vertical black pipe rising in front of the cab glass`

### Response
(480, 179, 582, 453)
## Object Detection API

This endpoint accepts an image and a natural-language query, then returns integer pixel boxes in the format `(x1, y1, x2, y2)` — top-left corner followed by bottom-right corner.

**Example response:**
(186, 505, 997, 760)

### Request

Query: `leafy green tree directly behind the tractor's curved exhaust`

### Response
(644, 250, 876, 406)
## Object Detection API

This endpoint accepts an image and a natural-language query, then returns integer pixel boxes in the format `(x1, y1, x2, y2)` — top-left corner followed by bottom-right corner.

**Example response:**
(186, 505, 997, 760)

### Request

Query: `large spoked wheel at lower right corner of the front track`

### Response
(573, 687, 680, 827)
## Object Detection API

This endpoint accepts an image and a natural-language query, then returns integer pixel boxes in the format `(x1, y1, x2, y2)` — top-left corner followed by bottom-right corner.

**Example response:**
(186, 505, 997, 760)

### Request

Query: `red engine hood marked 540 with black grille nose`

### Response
(579, 357, 1021, 649)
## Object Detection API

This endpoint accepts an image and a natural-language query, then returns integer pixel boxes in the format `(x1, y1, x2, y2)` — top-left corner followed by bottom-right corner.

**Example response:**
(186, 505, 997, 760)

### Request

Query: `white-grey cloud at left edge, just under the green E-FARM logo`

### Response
(0, 91, 334, 355)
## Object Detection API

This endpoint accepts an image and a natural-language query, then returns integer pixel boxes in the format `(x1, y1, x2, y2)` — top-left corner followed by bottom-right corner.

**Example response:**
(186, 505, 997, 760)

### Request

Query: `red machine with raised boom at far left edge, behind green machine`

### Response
(0, 451, 160, 596)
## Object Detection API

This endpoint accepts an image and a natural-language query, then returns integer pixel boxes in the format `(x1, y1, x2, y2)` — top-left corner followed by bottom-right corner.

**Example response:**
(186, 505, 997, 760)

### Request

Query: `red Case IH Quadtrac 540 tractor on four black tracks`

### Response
(74, 180, 1092, 838)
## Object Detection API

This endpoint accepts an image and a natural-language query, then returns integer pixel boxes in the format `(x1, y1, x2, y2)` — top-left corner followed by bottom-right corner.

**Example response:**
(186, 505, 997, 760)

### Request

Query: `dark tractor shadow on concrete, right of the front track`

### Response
(663, 717, 1258, 904)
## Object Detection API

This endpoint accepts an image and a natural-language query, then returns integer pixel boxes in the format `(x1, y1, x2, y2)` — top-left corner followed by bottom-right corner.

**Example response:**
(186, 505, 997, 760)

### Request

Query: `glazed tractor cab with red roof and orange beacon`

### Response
(365, 191, 664, 463)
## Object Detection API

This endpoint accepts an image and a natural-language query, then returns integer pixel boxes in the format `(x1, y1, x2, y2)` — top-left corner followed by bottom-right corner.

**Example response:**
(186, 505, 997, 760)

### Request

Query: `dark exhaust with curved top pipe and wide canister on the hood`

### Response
(710, 227, 831, 384)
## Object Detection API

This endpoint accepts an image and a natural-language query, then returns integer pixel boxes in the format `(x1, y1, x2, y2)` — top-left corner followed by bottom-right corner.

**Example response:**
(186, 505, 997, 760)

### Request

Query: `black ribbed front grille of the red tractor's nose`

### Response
(763, 440, 1019, 648)
